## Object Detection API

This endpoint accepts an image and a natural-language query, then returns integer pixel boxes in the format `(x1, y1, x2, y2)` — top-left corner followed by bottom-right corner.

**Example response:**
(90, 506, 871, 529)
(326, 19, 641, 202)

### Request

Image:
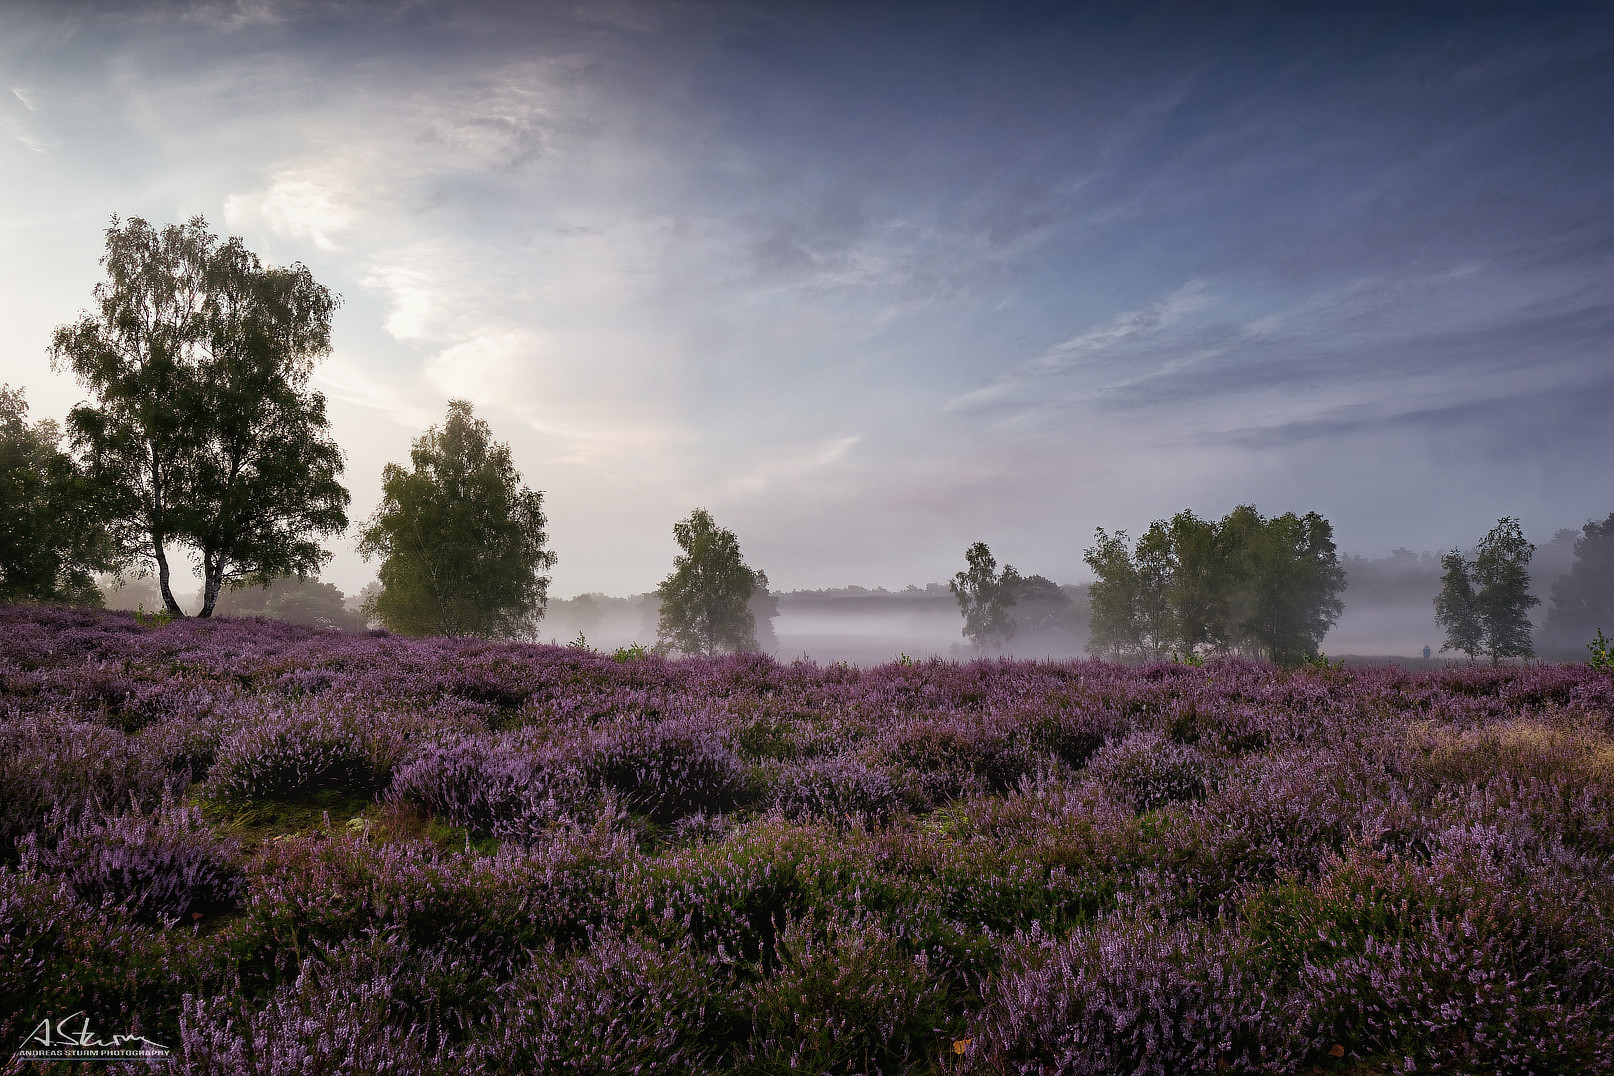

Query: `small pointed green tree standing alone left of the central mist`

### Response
(655, 508, 771, 657)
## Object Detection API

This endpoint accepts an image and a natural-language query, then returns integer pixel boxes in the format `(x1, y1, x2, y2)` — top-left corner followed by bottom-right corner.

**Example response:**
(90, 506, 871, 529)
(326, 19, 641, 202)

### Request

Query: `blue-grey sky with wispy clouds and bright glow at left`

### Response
(0, 0, 1614, 597)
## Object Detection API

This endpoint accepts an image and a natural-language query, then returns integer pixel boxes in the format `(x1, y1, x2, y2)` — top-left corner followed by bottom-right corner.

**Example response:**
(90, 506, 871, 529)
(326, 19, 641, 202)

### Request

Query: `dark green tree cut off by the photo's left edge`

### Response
(0, 386, 113, 605)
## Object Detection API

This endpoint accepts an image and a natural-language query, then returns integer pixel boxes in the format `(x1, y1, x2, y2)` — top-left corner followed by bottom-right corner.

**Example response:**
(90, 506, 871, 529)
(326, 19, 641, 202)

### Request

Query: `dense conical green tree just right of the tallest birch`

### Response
(358, 400, 555, 639)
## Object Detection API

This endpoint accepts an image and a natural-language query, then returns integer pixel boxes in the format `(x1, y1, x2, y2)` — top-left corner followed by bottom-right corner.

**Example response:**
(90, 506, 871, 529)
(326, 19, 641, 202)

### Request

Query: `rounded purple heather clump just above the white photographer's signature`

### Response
(23, 803, 240, 921)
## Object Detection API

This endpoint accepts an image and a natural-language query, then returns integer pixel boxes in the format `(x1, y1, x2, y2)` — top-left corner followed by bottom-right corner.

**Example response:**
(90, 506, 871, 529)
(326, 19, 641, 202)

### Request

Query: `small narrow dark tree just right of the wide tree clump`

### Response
(1435, 518, 1541, 665)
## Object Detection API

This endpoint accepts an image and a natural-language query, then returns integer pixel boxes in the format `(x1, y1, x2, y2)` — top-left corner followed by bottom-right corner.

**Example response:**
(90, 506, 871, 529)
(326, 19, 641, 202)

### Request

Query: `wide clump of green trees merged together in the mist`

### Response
(1085, 505, 1344, 663)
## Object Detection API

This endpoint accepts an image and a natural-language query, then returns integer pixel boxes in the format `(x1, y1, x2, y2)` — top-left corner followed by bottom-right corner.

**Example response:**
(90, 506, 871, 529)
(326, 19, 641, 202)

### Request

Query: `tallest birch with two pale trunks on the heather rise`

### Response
(50, 216, 349, 616)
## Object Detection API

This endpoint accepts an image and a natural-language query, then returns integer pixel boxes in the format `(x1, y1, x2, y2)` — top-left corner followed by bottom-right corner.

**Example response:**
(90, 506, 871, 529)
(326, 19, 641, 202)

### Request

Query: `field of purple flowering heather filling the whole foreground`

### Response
(0, 608, 1614, 1076)
